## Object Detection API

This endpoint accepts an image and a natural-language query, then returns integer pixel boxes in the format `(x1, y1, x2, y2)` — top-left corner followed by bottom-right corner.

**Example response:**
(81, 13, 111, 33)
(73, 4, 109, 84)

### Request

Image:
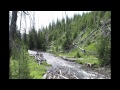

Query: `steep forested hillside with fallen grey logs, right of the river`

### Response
(43, 11, 111, 67)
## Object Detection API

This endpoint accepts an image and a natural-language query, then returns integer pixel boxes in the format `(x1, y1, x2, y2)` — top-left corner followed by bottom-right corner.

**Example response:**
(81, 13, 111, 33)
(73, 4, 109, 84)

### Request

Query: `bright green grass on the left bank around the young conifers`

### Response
(10, 52, 51, 79)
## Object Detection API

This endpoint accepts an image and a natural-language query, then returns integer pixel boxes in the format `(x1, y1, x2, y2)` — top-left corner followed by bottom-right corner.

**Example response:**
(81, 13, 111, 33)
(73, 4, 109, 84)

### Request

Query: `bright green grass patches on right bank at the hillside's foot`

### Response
(47, 43, 100, 67)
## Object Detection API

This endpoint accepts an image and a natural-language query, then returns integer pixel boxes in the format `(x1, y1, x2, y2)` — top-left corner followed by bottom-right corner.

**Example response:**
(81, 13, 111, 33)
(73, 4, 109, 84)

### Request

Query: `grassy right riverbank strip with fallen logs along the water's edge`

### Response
(47, 53, 111, 78)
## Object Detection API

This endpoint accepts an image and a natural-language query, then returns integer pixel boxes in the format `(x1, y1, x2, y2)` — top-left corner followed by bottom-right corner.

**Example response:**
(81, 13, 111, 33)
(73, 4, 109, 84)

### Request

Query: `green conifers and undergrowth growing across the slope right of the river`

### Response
(43, 11, 111, 65)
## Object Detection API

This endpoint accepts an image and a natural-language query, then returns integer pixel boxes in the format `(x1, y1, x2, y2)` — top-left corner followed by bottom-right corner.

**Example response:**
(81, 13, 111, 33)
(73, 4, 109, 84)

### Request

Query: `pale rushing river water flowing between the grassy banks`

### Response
(28, 50, 110, 79)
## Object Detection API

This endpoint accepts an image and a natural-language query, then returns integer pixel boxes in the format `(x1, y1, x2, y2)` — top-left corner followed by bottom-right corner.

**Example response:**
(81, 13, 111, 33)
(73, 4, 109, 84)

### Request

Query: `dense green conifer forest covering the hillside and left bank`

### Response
(9, 11, 111, 78)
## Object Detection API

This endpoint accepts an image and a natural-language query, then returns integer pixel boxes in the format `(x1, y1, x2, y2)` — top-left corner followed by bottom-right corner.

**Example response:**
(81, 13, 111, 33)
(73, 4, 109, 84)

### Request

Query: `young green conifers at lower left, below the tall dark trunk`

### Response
(10, 44, 30, 79)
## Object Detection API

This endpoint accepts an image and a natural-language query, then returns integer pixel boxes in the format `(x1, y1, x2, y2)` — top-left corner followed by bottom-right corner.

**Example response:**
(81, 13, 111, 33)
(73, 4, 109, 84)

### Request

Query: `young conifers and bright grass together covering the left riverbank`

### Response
(9, 34, 50, 79)
